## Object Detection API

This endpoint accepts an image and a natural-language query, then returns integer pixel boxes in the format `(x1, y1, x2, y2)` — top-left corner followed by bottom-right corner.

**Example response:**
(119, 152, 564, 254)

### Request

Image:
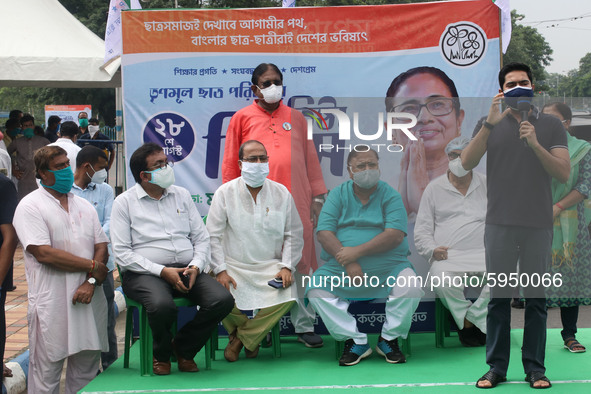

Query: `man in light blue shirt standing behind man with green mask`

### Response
(72, 145, 117, 370)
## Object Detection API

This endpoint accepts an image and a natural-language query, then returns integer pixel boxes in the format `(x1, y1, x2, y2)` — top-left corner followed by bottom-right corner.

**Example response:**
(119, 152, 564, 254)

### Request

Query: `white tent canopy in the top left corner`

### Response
(0, 0, 121, 88)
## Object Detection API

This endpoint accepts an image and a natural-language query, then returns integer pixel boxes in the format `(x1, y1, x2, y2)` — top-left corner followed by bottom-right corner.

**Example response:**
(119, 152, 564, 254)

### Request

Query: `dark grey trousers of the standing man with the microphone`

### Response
(484, 224, 552, 376)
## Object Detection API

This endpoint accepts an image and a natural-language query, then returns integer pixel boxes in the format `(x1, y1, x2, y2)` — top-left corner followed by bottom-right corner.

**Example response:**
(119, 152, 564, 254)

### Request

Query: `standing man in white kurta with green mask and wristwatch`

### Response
(14, 147, 109, 393)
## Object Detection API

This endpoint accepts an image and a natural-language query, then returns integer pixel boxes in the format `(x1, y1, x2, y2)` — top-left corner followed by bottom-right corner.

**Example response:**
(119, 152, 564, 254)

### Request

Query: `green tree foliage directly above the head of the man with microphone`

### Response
(503, 10, 552, 88)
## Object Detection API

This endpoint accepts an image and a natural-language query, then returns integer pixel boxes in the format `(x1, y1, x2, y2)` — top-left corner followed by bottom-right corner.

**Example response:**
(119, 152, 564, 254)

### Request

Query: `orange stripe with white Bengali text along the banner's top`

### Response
(122, 0, 499, 54)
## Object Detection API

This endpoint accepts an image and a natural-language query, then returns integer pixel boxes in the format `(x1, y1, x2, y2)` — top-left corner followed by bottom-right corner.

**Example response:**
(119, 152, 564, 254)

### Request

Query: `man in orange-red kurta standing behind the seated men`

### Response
(222, 63, 326, 347)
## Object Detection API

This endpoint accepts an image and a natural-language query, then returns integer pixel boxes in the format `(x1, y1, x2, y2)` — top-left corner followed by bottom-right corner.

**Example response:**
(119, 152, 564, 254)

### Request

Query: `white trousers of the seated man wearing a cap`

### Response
(429, 261, 490, 334)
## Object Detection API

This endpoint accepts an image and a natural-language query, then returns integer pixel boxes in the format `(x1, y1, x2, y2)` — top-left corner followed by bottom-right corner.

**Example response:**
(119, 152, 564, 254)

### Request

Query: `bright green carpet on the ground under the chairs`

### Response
(81, 328, 591, 394)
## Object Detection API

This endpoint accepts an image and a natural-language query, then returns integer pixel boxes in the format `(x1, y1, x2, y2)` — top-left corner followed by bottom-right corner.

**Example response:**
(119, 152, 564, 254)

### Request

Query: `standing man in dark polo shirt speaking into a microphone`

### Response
(461, 63, 570, 388)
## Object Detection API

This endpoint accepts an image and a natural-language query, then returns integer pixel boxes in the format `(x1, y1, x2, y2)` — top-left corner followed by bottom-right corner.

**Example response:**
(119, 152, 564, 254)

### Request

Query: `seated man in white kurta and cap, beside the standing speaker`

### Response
(414, 137, 490, 346)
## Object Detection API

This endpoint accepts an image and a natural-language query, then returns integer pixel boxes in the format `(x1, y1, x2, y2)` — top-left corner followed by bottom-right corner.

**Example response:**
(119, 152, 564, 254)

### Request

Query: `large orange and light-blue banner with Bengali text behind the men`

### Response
(122, 0, 501, 288)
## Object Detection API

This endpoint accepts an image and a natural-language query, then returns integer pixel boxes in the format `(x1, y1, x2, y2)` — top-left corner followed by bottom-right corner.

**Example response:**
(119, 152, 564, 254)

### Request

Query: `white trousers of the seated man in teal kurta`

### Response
(308, 268, 425, 345)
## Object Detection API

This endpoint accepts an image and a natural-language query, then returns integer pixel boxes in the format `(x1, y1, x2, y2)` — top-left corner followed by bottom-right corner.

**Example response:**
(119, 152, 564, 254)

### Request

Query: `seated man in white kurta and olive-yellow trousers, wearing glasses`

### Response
(207, 141, 304, 361)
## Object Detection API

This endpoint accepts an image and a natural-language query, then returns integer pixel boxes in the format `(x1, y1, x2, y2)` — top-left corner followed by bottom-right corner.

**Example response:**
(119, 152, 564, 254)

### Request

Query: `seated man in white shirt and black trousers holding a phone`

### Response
(111, 143, 234, 375)
